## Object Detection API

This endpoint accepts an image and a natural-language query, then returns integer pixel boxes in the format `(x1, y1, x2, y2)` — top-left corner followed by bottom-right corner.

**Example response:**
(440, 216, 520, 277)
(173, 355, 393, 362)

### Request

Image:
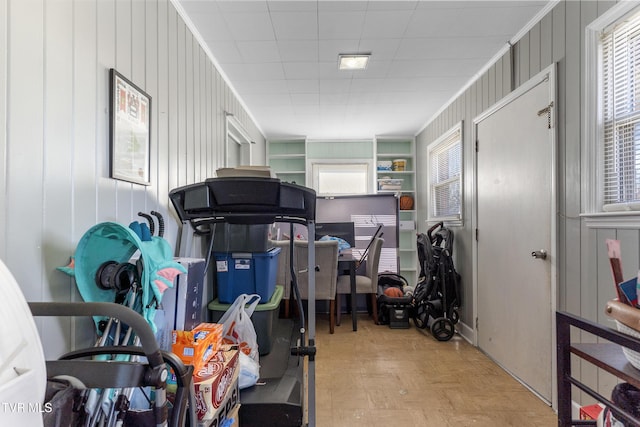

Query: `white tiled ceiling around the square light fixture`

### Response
(172, 0, 546, 138)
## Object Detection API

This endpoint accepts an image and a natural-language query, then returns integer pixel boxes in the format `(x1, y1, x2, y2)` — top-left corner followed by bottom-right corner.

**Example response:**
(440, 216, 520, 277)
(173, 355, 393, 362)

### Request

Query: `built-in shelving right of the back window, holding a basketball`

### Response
(375, 137, 418, 285)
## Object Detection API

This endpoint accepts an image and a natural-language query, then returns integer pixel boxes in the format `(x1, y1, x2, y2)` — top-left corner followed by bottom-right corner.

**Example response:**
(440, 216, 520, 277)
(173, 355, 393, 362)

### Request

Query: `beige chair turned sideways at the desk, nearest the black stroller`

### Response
(337, 237, 384, 325)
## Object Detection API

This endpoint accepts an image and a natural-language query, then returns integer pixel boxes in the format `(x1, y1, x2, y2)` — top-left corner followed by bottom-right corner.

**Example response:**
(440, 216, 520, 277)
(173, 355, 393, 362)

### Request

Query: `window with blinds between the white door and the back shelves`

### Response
(428, 123, 462, 221)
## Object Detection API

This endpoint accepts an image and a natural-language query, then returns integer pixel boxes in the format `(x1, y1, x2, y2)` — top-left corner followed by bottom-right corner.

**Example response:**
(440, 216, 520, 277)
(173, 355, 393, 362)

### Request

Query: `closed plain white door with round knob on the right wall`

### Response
(476, 67, 555, 402)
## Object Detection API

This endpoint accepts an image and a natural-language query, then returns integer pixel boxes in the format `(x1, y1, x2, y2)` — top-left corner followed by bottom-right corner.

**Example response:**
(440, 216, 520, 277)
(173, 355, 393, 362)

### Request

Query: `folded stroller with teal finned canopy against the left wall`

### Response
(30, 211, 197, 427)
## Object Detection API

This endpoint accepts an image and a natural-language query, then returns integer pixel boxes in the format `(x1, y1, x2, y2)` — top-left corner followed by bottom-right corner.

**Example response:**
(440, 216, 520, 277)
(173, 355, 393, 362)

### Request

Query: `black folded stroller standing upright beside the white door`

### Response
(412, 222, 460, 341)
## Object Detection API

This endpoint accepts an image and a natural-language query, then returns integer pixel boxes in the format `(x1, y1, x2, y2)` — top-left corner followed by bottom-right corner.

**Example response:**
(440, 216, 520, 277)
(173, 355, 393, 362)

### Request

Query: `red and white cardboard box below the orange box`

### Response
(193, 348, 240, 427)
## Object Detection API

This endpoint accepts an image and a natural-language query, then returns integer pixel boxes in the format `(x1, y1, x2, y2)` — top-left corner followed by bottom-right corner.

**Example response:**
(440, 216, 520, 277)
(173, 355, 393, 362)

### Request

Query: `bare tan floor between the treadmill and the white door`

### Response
(316, 314, 558, 427)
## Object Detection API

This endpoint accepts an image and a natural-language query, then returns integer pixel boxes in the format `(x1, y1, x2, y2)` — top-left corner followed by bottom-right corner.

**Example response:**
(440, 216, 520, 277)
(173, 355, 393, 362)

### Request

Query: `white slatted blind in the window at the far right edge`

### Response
(602, 14, 640, 205)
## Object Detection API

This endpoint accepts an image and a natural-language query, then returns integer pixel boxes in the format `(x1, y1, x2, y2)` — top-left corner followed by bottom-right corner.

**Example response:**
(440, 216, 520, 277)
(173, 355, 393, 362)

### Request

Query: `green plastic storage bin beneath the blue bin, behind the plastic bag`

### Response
(207, 285, 284, 356)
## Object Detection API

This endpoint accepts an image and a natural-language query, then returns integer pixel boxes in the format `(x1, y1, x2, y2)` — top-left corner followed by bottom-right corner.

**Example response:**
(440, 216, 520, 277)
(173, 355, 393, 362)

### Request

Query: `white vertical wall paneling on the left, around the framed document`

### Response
(0, 0, 266, 357)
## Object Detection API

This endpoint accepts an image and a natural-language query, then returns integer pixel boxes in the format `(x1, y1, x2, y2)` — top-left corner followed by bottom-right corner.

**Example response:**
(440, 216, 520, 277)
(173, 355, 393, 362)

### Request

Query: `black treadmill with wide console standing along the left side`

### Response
(169, 176, 316, 427)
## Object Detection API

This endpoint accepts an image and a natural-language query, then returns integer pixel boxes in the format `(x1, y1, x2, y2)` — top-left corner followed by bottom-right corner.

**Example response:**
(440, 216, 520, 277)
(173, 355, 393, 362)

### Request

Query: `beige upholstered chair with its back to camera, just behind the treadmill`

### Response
(293, 240, 338, 334)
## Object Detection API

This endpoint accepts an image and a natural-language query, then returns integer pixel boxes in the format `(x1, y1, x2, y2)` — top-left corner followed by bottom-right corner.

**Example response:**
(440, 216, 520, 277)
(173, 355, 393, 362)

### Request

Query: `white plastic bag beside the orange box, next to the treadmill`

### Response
(218, 294, 260, 388)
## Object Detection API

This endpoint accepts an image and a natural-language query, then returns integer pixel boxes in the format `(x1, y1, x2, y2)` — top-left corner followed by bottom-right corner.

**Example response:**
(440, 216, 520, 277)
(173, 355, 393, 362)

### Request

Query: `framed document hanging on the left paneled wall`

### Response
(109, 68, 151, 185)
